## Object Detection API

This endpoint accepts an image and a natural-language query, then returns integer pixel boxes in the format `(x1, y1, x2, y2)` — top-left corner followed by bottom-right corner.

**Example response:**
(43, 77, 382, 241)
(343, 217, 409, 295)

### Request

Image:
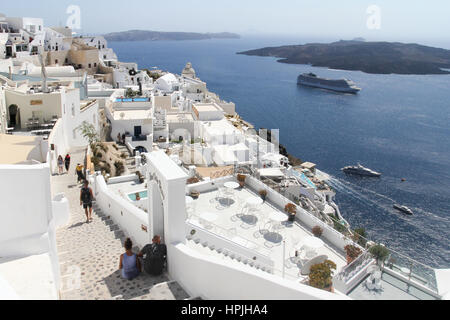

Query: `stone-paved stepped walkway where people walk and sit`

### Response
(51, 149, 189, 300)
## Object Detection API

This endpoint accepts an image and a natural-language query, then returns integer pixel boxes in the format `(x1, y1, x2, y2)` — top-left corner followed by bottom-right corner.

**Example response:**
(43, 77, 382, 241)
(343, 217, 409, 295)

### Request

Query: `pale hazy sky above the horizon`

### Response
(0, 0, 450, 42)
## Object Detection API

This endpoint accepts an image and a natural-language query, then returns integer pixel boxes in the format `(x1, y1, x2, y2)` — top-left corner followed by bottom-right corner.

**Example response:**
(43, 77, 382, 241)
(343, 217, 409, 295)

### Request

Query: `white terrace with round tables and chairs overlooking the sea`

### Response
(186, 177, 347, 282)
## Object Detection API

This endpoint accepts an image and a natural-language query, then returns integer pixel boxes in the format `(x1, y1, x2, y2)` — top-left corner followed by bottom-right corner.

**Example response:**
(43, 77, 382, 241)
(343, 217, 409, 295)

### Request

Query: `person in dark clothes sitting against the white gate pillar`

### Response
(138, 236, 167, 276)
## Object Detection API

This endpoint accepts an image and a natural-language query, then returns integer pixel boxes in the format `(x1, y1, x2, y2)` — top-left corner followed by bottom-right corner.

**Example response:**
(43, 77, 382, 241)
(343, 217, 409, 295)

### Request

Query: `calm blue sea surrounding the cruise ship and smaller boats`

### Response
(110, 38, 450, 268)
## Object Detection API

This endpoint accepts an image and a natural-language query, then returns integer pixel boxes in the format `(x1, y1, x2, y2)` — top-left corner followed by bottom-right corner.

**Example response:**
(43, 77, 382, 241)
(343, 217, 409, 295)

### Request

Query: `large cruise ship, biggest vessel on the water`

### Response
(297, 73, 361, 93)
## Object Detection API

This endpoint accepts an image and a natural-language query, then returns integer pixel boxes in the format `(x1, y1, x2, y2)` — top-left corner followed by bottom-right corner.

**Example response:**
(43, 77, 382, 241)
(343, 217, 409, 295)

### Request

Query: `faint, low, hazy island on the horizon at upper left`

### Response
(104, 30, 240, 41)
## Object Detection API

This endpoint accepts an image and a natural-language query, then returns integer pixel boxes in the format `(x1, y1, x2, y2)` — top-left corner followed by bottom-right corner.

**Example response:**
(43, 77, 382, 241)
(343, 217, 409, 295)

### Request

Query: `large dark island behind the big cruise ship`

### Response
(238, 39, 450, 75)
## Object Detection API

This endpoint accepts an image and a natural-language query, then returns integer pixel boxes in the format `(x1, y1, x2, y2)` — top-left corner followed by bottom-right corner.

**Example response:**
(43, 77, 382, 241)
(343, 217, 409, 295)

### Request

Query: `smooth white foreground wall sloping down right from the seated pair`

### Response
(168, 243, 350, 300)
